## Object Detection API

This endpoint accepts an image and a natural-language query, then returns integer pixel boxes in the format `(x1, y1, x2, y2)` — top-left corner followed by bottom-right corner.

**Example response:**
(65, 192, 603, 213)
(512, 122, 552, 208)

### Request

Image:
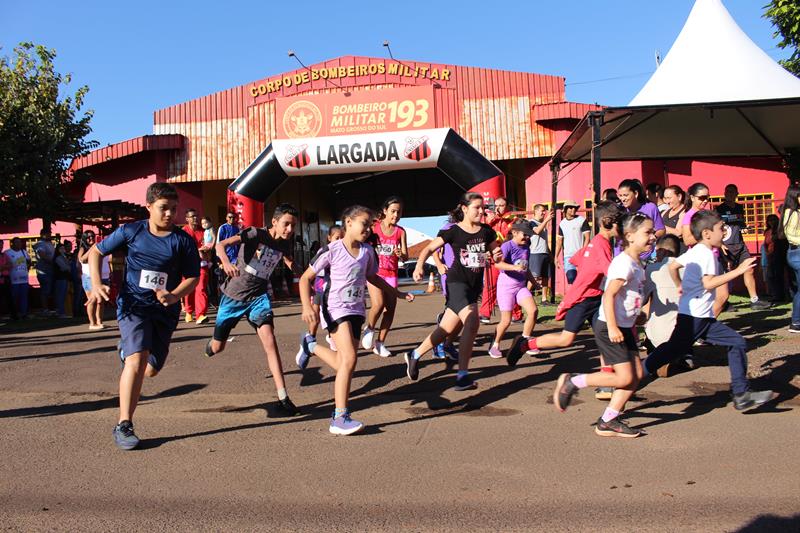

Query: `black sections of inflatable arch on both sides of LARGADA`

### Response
(228, 129, 503, 202)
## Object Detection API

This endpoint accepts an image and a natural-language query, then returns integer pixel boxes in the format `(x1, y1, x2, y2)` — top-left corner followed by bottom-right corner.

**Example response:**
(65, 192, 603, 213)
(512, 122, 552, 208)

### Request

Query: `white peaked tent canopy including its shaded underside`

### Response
(553, 0, 800, 164)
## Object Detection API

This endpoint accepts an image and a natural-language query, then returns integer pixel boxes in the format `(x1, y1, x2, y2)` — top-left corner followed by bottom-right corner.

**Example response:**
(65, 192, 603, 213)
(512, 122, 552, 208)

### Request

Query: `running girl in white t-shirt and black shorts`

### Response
(553, 213, 656, 437)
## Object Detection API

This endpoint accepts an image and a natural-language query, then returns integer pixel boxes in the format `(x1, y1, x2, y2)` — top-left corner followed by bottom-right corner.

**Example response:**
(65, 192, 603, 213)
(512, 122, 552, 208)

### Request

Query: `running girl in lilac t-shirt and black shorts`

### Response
(296, 205, 414, 435)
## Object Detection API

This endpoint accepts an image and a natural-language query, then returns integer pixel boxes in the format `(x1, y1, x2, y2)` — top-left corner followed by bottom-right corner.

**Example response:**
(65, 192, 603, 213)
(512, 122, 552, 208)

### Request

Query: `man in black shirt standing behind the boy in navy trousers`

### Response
(715, 183, 770, 309)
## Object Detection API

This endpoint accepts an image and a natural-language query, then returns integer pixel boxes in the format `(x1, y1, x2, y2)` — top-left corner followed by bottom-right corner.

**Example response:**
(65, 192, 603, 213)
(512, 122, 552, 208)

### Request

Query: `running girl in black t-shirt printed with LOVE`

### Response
(405, 193, 500, 391)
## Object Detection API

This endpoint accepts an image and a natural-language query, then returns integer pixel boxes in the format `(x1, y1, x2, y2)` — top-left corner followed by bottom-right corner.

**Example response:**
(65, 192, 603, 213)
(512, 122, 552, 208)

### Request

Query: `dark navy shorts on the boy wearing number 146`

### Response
(117, 308, 178, 370)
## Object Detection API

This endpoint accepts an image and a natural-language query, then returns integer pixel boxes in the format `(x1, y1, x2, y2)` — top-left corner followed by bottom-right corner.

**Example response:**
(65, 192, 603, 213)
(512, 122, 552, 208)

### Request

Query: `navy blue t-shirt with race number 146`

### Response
(97, 220, 200, 315)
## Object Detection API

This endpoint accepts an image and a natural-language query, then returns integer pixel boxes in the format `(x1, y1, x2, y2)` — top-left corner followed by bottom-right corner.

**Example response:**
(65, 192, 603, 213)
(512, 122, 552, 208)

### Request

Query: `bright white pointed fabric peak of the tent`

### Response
(628, 0, 800, 106)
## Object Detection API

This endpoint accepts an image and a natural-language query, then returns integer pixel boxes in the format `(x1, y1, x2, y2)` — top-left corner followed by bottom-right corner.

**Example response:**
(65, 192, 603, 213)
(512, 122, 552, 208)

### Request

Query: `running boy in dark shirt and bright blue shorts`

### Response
(205, 204, 300, 416)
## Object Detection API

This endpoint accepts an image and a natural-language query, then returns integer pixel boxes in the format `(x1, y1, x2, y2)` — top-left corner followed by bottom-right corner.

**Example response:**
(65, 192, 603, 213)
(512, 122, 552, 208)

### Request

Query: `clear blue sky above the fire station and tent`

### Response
(0, 0, 787, 233)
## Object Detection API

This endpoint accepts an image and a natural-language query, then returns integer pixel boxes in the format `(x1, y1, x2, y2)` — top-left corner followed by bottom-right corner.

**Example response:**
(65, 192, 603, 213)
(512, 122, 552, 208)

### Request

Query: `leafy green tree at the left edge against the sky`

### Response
(0, 42, 97, 224)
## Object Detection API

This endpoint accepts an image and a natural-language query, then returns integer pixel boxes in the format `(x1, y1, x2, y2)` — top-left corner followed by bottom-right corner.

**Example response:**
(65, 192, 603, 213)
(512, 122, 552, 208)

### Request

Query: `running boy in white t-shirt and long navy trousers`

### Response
(644, 211, 776, 411)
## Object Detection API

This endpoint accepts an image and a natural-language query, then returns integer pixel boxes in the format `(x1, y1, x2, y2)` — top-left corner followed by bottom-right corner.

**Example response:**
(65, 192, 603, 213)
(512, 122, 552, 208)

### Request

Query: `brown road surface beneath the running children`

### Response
(0, 288, 800, 531)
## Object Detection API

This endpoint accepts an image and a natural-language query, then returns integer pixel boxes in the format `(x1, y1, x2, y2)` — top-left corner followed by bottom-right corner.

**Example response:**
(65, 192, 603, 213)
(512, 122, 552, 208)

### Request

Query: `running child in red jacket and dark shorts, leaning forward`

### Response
(506, 201, 624, 370)
